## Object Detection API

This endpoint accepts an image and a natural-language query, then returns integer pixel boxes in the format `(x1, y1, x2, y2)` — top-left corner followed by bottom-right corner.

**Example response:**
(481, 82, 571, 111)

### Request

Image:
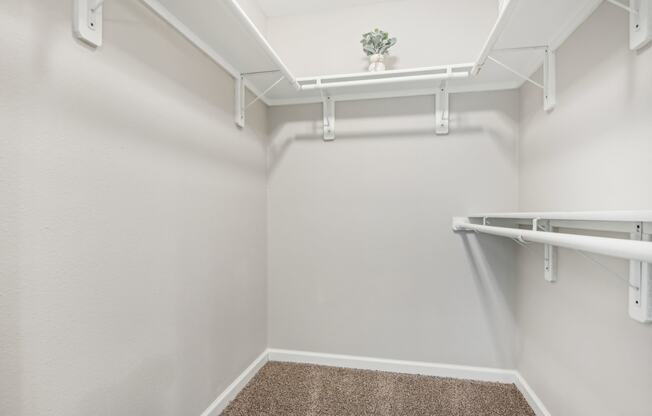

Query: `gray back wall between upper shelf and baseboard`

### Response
(268, 91, 519, 368)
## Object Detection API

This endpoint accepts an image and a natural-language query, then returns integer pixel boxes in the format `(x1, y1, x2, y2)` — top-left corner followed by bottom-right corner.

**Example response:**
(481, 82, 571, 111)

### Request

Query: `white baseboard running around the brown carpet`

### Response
(201, 348, 551, 416)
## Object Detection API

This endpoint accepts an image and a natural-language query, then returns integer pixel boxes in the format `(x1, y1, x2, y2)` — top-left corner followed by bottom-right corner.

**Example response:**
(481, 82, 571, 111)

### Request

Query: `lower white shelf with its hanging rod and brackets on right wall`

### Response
(453, 210, 652, 323)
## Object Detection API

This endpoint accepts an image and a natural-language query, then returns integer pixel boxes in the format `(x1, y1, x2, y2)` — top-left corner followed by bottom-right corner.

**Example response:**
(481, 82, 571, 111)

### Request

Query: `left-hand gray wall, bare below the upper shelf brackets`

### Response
(0, 0, 267, 416)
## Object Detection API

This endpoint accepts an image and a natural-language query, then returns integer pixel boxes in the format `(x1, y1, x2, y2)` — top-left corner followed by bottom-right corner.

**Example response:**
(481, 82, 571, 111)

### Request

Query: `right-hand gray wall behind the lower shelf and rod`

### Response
(517, 4, 652, 416)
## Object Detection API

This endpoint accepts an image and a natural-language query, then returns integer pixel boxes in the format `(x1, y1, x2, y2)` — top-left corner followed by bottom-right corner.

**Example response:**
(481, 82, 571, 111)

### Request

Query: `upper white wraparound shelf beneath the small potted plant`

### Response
(141, 0, 601, 105)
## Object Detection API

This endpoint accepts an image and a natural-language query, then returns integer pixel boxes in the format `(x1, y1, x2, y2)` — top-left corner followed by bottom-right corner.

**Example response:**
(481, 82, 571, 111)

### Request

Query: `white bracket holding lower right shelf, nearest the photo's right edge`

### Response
(629, 223, 652, 323)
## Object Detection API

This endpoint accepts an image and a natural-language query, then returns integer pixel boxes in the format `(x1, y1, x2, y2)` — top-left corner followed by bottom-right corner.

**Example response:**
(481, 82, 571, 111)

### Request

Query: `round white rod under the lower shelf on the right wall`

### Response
(453, 221, 652, 263)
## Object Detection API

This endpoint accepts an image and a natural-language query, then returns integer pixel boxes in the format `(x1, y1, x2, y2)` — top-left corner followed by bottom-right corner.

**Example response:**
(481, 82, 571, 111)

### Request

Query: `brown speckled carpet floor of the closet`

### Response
(222, 362, 534, 416)
